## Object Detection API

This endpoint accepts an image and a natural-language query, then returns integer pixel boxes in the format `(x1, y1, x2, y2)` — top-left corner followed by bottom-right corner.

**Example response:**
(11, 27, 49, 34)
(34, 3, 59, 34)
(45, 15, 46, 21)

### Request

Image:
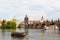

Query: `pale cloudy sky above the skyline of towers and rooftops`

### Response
(0, 0, 60, 20)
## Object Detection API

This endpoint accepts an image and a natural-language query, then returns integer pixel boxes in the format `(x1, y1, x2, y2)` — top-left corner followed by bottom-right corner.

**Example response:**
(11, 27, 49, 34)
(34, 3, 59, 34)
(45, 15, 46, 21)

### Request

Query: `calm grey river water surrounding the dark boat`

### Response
(0, 29, 60, 40)
